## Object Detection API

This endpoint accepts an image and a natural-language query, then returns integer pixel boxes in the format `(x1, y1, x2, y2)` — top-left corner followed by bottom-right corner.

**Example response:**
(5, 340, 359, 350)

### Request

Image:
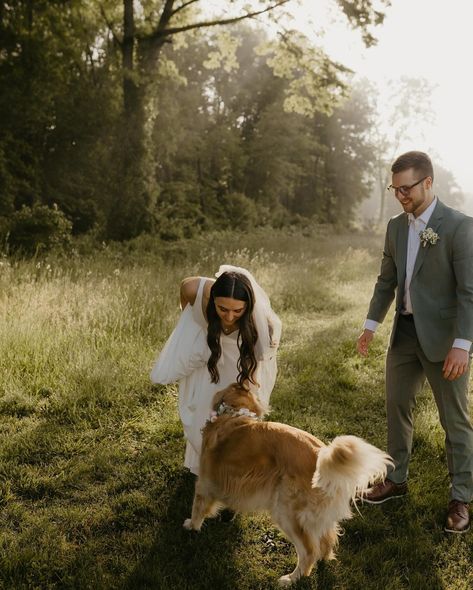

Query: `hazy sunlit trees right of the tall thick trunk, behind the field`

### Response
(149, 27, 373, 231)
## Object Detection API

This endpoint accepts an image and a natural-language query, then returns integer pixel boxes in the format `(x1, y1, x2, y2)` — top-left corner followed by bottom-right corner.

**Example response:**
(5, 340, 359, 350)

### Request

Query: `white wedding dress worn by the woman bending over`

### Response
(151, 269, 281, 475)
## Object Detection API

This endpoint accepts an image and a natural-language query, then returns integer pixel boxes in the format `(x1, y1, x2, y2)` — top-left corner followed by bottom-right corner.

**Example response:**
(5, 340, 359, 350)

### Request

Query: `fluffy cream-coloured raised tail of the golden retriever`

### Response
(312, 436, 392, 499)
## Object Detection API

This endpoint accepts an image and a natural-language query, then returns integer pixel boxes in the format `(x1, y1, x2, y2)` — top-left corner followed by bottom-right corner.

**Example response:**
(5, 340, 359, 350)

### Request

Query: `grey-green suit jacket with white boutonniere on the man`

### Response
(368, 200, 473, 362)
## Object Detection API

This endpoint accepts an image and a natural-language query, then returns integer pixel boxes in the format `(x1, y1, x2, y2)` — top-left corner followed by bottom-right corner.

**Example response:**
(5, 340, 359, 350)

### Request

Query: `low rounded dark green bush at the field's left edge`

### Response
(7, 205, 72, 255)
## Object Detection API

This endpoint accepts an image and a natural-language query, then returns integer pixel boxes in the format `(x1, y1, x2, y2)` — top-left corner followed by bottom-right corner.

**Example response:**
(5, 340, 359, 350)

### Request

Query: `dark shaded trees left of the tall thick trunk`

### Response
(0, 0, 117, 233)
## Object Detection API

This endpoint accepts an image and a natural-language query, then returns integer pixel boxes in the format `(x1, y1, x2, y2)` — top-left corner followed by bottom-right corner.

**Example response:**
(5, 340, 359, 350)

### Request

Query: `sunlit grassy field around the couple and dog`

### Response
(0, 231, 473, 590)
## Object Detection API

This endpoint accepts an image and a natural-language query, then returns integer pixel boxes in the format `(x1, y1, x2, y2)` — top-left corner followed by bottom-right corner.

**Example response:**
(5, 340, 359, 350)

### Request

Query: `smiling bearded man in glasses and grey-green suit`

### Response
(357, 151, 473, 533)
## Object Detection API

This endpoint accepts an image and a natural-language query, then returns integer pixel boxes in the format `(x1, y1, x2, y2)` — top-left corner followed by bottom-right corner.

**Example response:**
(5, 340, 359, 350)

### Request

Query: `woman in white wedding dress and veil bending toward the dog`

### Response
(151, 265, 281, 475)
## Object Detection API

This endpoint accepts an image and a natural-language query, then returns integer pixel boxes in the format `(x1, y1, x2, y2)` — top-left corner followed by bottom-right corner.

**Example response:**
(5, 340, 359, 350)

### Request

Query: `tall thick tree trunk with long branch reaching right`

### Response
(108, 0, 288, 239)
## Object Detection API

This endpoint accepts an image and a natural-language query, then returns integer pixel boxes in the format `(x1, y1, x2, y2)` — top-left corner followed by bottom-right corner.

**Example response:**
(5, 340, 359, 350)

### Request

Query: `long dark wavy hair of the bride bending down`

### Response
(206, 272, 258, 385)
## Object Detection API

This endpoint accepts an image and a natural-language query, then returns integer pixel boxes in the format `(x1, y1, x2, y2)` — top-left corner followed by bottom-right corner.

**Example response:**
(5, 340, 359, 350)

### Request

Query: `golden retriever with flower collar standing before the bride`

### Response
(184, 383, 391, 586)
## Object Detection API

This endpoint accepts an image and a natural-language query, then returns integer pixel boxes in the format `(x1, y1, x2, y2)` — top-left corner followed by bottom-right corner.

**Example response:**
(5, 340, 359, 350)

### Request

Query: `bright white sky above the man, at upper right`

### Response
(293, 0, 473, 199)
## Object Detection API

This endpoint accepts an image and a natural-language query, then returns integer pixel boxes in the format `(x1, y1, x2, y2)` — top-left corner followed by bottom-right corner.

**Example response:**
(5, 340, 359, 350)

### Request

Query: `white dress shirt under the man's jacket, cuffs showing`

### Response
(364, 197, 471, 351)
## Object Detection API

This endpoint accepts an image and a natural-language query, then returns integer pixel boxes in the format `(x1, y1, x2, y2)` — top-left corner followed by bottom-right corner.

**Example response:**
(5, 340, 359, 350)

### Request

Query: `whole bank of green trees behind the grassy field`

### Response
(0, 0, 390, 240)
